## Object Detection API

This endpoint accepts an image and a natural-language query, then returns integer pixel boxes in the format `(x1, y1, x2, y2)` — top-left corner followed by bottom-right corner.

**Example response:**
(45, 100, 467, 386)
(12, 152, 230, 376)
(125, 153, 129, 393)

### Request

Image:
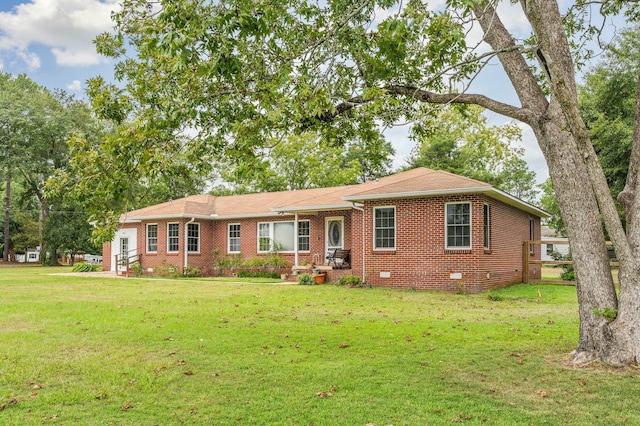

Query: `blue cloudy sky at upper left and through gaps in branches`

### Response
(0, 0, 548, 182)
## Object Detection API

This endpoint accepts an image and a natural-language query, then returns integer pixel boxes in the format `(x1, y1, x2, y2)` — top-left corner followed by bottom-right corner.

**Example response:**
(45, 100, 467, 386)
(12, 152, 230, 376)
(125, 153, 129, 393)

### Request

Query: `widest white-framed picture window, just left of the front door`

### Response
(258, 220, 311, 252)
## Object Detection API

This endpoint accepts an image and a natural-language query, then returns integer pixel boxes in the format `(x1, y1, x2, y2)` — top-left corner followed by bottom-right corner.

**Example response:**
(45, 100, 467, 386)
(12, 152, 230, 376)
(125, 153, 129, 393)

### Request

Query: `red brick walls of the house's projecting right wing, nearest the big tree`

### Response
(352, 195, 540, 292)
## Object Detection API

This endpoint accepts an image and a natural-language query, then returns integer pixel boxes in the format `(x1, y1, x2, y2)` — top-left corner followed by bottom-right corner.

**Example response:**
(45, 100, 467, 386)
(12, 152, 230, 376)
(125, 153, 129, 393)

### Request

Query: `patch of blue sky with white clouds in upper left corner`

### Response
(0, 0, 117, 96)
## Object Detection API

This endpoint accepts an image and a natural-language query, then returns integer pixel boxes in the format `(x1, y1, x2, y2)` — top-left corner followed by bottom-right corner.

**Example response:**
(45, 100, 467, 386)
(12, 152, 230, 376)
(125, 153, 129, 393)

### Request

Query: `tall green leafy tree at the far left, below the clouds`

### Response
(0, 73, 100, 260)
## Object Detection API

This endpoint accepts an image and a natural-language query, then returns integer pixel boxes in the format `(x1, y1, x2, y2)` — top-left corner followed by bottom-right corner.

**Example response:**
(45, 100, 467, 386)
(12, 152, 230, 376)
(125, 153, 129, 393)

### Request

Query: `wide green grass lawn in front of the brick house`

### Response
(0, 267, 640, 426)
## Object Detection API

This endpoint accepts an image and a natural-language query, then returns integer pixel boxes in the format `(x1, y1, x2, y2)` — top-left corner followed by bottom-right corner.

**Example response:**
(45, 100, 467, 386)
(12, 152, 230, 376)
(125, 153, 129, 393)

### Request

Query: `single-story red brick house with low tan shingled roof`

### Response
(103, 168, 548, 292)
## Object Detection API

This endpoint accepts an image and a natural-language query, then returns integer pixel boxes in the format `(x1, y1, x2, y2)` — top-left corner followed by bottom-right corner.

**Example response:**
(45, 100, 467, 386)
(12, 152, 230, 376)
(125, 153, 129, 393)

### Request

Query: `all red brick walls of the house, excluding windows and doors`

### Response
(103, 194, 540, 292)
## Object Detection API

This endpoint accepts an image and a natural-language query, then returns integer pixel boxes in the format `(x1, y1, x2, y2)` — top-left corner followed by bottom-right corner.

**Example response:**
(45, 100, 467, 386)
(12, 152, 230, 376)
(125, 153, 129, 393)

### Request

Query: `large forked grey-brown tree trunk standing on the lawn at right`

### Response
(474, 0, 640, 364)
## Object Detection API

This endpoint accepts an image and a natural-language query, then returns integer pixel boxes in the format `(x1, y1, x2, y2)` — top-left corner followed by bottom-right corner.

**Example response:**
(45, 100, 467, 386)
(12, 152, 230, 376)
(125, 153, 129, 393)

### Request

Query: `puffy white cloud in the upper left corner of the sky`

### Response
(0, 0, 117, 69)
